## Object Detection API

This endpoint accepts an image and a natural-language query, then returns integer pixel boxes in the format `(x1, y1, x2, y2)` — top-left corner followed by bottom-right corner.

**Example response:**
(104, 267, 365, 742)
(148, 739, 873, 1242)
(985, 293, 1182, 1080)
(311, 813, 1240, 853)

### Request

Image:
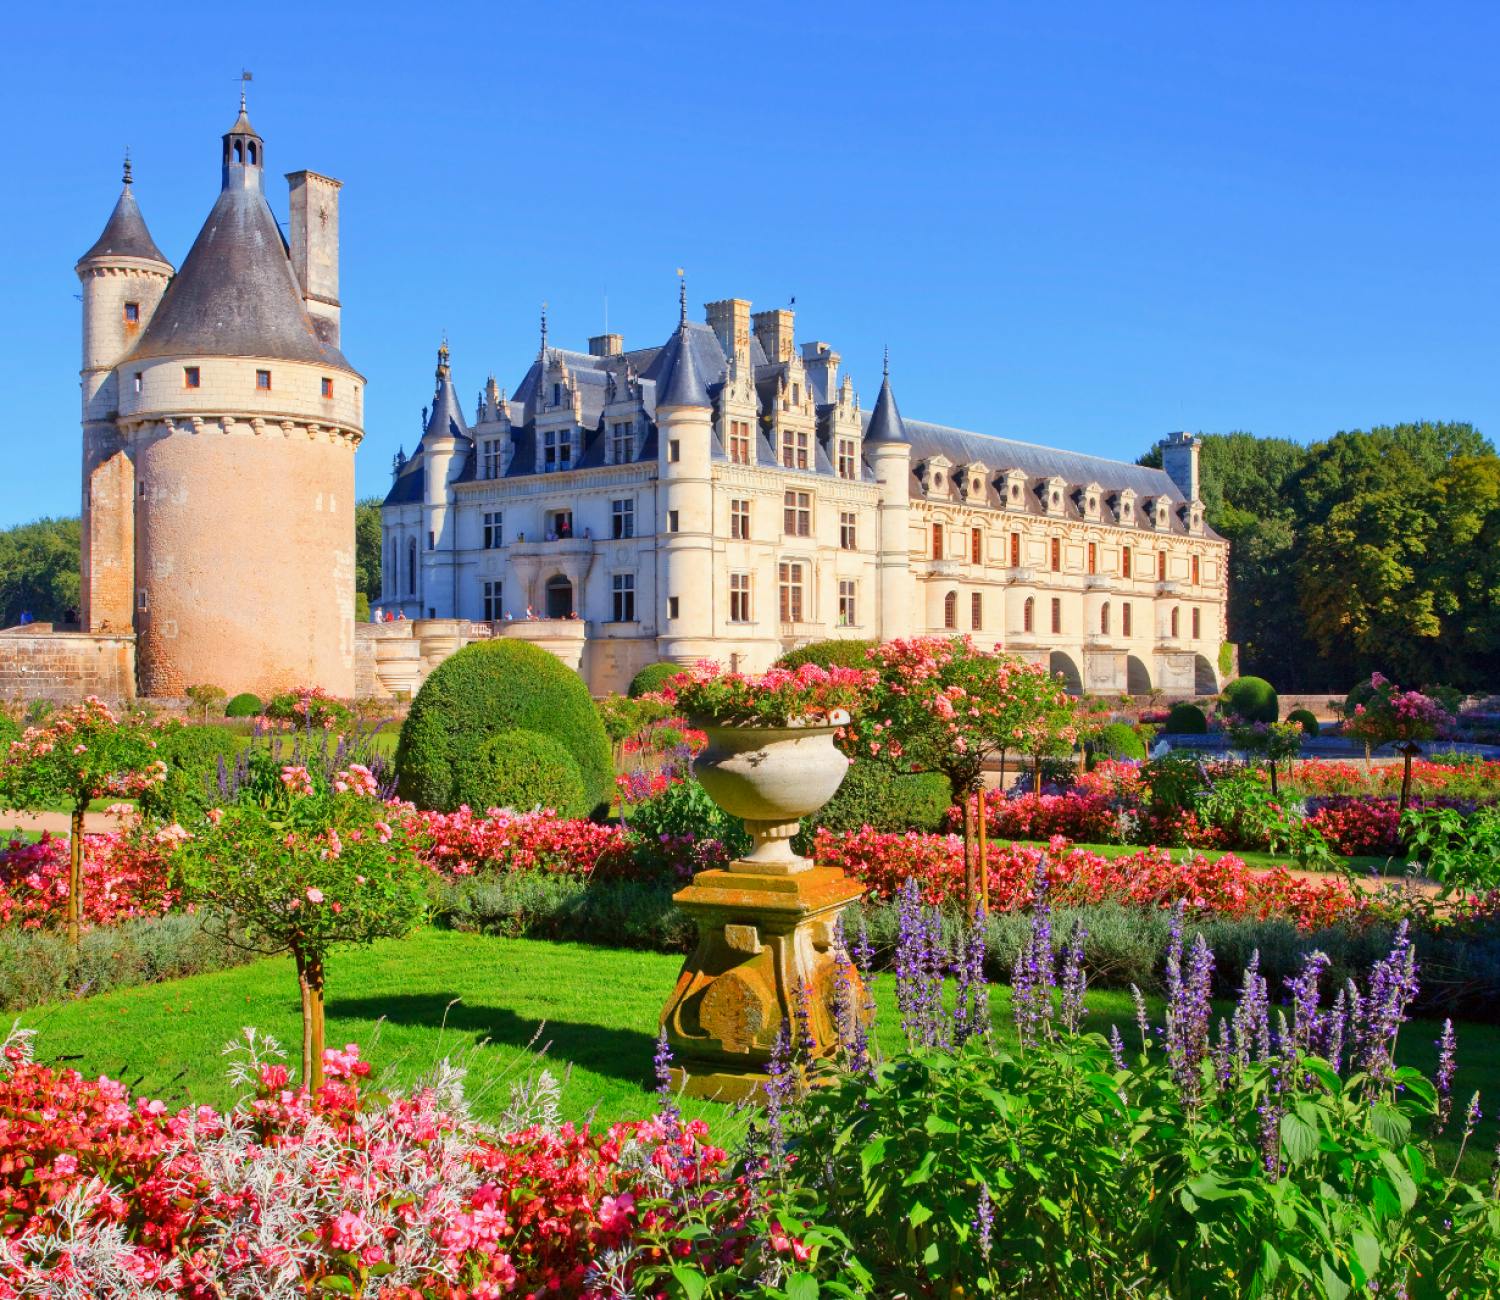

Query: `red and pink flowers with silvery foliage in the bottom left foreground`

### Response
(0, 1030, 738, 1300)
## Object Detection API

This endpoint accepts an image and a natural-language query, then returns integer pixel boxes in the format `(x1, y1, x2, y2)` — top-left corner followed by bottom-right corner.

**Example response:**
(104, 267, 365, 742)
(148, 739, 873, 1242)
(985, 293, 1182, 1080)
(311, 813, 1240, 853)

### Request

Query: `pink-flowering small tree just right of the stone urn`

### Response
(851, 637, 1074, 909)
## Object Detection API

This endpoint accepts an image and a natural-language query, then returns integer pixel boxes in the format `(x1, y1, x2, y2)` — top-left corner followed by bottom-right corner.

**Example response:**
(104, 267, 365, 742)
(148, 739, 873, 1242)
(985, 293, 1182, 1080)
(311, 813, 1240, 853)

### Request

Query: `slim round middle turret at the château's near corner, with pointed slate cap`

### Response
(656, 282, 714, 664)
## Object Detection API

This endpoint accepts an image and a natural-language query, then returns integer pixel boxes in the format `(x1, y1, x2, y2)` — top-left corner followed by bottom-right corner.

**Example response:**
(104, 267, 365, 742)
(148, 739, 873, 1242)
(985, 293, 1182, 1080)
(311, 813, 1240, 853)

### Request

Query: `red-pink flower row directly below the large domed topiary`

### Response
(402, 807, 630, 877)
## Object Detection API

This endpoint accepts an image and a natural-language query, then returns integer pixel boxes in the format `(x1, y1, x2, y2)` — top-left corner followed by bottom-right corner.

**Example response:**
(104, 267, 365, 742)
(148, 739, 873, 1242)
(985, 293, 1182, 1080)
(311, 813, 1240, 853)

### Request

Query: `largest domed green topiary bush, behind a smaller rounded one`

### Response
(396, 639, 614, 814)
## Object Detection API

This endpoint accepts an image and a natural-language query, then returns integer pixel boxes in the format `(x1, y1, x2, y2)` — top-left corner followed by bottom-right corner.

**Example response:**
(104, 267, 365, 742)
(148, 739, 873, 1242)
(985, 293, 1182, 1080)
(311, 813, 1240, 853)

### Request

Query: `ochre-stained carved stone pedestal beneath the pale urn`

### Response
(662, 859, 864, 1102)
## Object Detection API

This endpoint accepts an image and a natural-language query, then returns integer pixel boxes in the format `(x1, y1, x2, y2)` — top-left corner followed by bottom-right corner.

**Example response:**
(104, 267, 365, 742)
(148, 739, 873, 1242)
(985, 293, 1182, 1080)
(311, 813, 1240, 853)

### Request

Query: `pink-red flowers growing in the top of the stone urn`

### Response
(657, 663, 875, 727)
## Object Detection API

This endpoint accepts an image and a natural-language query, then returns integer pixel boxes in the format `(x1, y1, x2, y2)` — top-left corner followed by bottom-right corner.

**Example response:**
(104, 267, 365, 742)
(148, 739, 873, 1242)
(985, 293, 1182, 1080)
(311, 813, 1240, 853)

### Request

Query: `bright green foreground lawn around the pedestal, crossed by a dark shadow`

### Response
(11, 930, 1500, 1177)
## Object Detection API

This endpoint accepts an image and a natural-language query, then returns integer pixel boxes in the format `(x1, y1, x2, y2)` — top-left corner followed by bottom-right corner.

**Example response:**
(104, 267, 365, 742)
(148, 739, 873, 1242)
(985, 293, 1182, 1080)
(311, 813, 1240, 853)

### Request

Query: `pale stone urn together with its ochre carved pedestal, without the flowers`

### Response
(662, 714, 864, 1102)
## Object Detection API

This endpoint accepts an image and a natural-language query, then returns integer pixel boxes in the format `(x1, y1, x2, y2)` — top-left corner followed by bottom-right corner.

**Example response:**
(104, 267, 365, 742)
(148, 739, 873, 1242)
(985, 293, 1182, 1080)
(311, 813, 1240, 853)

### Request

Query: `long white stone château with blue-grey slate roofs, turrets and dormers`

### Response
(381, 288, 1229, 694)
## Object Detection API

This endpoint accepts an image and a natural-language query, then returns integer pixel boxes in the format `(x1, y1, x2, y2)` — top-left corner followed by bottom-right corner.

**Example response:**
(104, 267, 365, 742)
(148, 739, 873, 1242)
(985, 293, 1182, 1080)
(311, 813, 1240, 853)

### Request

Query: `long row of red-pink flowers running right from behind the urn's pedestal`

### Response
(816, 831, 1365, 930)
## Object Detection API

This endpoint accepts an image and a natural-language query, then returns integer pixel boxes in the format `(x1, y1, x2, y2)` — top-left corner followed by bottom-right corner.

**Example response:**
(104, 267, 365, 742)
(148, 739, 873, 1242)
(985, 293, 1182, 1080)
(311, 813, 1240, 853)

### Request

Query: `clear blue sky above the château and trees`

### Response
(0, 0, 1500, 525)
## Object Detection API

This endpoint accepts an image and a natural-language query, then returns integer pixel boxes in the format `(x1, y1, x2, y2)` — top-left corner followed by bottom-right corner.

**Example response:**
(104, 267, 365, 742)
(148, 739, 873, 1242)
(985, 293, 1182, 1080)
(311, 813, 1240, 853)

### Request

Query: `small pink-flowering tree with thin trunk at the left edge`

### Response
(0, 696, 169, 946)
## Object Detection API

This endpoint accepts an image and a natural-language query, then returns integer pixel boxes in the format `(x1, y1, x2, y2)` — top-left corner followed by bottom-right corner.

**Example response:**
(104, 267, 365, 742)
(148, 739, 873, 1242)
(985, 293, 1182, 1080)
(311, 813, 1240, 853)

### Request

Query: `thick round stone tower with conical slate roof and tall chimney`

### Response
(80, 100, 365, 696)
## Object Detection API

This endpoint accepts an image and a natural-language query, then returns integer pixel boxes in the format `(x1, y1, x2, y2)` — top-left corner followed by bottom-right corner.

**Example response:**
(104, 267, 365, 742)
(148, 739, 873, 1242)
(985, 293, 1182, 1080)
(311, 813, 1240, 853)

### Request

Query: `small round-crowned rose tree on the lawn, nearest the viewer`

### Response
(182, 756, 426, 1092)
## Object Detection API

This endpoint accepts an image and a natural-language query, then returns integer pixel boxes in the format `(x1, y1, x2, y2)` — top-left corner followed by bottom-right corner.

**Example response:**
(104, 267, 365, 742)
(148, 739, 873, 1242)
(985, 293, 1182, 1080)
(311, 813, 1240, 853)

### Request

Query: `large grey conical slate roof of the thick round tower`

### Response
(132, 187, 354, 372)
